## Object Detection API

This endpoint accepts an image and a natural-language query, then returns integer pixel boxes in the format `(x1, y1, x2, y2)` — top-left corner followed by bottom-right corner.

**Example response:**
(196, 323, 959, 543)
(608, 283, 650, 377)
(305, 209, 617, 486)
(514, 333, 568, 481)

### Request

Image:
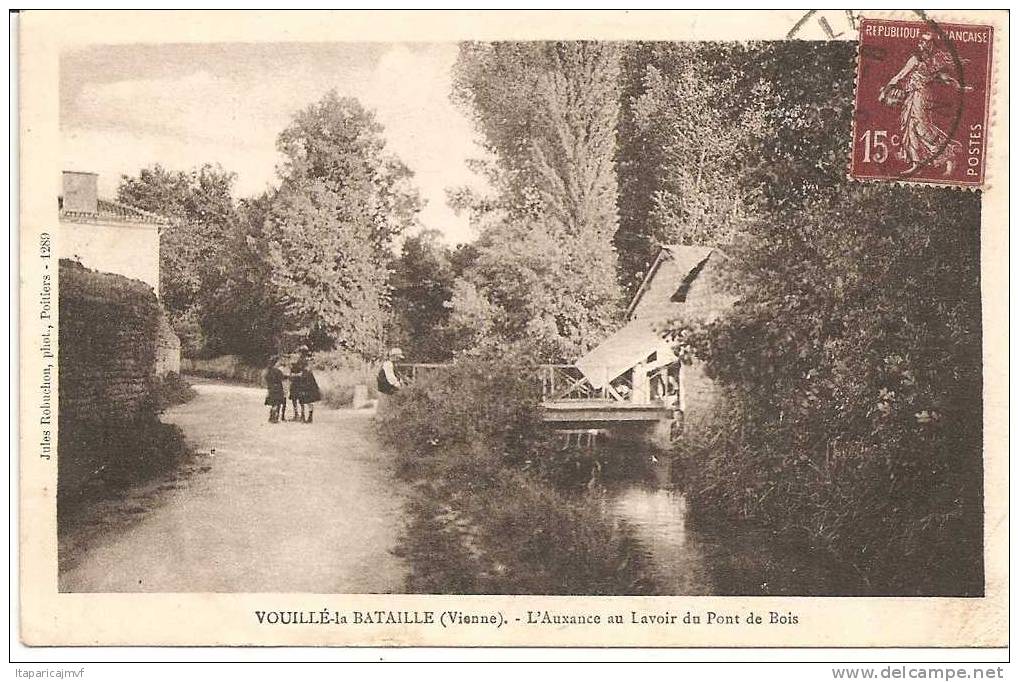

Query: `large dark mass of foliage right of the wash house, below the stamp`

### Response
(646, 44, 982, 593)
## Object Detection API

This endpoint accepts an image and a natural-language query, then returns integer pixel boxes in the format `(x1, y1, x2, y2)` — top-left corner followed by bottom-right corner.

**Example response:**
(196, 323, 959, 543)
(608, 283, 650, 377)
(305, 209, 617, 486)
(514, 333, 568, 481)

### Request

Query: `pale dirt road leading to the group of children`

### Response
(60, 381, 406, 593)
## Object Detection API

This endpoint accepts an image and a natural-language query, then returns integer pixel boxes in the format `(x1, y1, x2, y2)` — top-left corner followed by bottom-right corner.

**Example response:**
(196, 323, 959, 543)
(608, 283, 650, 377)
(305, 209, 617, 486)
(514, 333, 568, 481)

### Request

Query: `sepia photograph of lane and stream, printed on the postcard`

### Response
(58, 31, 983, 595)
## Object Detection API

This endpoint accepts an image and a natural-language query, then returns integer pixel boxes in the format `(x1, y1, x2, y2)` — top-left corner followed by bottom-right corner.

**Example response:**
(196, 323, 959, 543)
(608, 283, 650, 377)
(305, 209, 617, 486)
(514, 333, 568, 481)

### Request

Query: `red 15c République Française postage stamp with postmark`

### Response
(850, 19, 994, 187)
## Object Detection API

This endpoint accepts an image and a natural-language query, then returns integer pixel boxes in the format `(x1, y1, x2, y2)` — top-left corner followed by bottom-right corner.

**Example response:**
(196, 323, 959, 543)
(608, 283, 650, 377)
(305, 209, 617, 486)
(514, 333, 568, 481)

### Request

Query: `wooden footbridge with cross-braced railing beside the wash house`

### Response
(396, 363, 682, 427)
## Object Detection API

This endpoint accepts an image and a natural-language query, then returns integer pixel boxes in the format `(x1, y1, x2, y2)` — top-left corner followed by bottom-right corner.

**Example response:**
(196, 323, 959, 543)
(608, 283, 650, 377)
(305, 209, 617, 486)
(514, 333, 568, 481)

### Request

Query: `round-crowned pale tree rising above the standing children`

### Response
(266, 92, 420, 356)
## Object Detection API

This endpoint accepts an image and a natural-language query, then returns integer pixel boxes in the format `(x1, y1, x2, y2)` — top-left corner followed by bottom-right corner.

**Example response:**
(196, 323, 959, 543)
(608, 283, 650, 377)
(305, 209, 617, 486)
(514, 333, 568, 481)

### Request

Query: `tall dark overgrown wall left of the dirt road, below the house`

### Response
(57, 260, 186, 509)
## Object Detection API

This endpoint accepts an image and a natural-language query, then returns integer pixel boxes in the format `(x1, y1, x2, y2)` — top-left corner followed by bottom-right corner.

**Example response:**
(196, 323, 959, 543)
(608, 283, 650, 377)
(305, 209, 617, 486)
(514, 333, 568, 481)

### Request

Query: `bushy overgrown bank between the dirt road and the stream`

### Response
(380, 350, 654, 594)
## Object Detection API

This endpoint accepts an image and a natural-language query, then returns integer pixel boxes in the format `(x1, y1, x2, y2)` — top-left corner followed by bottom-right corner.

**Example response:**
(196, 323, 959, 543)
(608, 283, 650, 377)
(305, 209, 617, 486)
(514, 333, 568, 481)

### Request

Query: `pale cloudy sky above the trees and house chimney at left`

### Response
(60, 43, 482, 244)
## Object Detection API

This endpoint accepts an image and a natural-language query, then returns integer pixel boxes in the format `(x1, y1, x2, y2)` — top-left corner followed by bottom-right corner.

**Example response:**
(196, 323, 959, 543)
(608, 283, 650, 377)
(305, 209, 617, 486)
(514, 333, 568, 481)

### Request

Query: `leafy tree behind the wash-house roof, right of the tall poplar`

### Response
(615, 43, 772, 293)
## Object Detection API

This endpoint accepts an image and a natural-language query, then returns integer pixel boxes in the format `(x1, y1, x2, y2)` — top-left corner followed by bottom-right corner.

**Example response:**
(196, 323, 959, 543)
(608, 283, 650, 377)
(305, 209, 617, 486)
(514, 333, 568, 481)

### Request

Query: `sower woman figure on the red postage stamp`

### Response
(877, 33, 972, 175)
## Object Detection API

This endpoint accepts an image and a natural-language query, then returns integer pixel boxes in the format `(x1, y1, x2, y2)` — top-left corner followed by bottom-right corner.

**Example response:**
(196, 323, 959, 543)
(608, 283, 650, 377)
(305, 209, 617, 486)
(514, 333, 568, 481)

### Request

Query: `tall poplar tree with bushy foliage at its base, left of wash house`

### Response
(451, 42, 620, 357)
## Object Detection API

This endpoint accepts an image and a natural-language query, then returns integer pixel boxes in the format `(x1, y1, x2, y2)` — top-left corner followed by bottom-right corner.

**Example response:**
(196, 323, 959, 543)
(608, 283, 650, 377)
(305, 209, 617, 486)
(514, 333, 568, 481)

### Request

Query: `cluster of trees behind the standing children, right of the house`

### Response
(118, 93, 421, 362)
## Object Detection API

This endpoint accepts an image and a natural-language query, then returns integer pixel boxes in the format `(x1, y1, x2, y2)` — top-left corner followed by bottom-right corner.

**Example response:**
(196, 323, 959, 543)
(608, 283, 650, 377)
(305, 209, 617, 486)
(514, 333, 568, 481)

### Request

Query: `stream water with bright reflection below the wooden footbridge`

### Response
(604, 457, 858, 595)
